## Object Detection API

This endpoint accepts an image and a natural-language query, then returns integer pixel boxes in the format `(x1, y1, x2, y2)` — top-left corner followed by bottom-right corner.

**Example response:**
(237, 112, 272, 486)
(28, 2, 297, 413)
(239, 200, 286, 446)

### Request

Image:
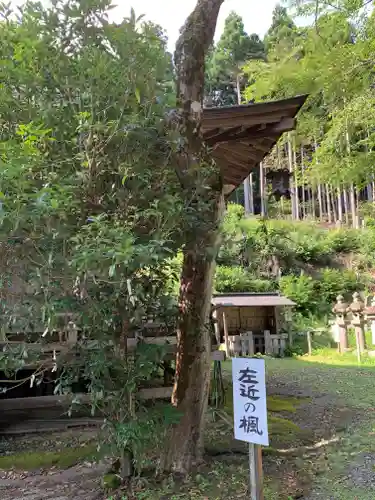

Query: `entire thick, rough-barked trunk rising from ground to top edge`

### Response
(161, 0, 224, 473)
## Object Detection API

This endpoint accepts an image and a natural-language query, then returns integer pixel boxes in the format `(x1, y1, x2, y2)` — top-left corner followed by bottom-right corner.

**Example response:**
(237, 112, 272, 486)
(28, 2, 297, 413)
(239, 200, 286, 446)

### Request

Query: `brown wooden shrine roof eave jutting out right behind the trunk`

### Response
(201, 95, 307, 194)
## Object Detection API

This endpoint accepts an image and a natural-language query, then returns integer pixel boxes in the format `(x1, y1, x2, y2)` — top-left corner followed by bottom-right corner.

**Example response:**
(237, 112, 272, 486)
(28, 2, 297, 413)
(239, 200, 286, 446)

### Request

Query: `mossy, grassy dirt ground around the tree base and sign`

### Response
(0, 359, 375, 500)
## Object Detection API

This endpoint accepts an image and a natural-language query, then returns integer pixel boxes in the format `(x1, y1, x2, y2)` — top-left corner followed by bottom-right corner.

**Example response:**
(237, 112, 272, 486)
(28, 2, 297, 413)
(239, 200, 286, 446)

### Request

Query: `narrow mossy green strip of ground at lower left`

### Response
(0, 445, 97, 471)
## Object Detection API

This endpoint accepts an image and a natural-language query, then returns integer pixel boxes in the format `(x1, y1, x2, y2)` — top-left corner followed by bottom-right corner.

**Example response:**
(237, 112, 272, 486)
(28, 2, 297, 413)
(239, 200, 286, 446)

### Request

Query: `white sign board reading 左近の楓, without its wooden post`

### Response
(232, 358, 269, 446)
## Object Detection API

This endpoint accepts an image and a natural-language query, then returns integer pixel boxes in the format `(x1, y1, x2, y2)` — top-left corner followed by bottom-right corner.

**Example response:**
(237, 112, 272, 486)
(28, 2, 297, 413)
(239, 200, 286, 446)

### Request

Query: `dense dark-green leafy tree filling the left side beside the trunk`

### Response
(0, 0, 183, 476)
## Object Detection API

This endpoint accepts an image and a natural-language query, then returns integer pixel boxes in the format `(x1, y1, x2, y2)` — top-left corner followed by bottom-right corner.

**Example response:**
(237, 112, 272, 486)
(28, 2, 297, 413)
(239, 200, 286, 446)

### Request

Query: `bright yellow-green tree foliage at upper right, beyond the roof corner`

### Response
(244, 0, 375, 193)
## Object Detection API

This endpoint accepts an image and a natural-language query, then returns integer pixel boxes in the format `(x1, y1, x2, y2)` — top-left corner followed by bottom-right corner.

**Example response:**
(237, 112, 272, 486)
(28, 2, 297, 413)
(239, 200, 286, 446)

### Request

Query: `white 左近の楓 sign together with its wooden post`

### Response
(232, 358, 269, 500)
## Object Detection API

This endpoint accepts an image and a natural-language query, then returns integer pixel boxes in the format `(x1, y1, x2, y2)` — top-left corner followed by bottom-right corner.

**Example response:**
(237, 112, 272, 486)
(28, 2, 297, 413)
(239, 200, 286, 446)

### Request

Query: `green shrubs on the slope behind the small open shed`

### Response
(215, 205, 375, 318)
